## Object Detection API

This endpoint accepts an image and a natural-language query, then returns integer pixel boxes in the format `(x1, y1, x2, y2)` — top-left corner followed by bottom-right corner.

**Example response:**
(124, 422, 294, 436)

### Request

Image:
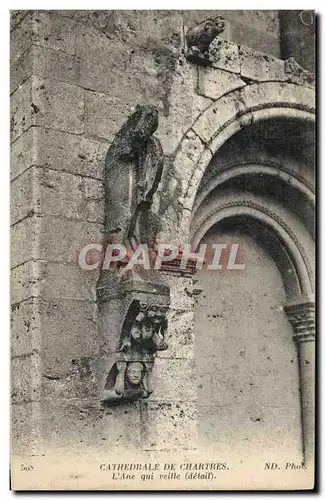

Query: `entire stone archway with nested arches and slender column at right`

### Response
(158, 78, 315, 464)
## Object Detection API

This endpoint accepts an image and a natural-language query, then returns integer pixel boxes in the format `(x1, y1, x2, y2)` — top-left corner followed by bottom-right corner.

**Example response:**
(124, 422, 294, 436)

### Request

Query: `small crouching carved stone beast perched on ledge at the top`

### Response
(186, 16, 225, 54)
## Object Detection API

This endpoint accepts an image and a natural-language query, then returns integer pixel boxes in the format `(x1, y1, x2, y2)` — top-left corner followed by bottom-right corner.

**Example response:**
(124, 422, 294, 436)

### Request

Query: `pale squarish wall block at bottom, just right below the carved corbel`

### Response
(141, 401, 197, 450)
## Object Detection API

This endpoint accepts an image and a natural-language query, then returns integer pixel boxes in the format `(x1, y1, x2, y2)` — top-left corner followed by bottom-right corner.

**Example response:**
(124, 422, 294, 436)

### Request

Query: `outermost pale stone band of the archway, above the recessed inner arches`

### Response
(167, 82, 315, 239)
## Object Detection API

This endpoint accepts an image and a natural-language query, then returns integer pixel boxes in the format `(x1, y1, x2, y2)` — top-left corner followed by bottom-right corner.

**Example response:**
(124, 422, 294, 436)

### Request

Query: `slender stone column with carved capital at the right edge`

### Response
(284, 297, 315, 467)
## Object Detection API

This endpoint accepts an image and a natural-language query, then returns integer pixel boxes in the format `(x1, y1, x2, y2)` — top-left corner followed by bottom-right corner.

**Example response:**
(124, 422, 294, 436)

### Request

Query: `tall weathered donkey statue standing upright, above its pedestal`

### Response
(104, 106, 164, 248)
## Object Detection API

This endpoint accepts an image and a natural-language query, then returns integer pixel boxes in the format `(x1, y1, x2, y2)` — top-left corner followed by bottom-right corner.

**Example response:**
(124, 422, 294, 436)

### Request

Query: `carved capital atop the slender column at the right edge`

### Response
(283, 297, 315, 342)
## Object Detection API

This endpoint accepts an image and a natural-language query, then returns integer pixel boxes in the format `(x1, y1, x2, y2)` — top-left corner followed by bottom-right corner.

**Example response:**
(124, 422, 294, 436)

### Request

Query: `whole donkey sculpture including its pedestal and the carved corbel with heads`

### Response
(97, 106, 170, 404)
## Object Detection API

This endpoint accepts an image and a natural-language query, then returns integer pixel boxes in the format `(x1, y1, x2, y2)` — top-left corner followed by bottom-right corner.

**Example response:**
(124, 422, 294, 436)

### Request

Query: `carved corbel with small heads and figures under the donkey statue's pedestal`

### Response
(101, 300, 168, 403)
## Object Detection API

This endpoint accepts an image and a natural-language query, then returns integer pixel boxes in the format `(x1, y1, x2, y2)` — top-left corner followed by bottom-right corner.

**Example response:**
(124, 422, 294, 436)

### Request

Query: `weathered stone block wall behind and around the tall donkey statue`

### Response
(11, 11, 314, 460)
